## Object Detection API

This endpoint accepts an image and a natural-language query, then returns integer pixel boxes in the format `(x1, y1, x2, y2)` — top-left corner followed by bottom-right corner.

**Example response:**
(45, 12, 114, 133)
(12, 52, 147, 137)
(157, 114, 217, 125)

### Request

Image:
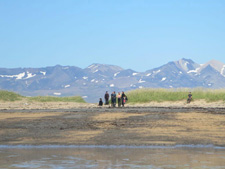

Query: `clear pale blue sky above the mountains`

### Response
(0, 0, 225, 71)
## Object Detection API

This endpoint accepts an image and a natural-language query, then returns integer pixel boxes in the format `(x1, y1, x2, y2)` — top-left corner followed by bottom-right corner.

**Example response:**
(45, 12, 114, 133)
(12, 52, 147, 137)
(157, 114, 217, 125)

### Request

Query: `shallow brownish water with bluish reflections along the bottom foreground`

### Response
(0, 145, 225, 169)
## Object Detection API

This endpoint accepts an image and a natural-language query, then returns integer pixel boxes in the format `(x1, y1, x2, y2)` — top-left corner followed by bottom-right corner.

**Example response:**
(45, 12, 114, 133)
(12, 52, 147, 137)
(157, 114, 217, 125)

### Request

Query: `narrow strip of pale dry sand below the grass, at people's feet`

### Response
(0, 99, 225, 110)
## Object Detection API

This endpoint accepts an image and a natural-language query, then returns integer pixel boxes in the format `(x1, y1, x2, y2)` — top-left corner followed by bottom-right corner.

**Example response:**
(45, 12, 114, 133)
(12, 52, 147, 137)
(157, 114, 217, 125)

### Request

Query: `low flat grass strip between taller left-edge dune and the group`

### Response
(28, 96, 86, 103)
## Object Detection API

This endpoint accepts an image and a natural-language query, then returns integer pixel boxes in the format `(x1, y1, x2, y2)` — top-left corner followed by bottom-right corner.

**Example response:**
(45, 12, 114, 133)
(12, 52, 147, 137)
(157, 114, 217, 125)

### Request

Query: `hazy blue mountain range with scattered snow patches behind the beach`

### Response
(0, 58, 225, 103)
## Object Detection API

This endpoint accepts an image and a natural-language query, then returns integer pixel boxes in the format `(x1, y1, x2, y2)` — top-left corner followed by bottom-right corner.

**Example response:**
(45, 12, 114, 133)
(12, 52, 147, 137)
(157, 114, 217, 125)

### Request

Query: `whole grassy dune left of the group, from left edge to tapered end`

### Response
(0, 90, 85, 103)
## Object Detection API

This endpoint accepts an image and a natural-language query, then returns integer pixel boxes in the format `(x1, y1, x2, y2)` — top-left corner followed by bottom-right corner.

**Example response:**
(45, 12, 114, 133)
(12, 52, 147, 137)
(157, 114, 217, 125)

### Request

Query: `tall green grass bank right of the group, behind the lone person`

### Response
(127, 88, 225, 103)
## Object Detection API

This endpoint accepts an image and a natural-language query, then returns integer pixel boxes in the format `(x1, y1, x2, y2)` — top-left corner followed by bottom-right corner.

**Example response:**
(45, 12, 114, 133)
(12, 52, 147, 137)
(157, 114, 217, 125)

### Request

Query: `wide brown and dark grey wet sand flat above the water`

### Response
(0, 105, 225, 147)
